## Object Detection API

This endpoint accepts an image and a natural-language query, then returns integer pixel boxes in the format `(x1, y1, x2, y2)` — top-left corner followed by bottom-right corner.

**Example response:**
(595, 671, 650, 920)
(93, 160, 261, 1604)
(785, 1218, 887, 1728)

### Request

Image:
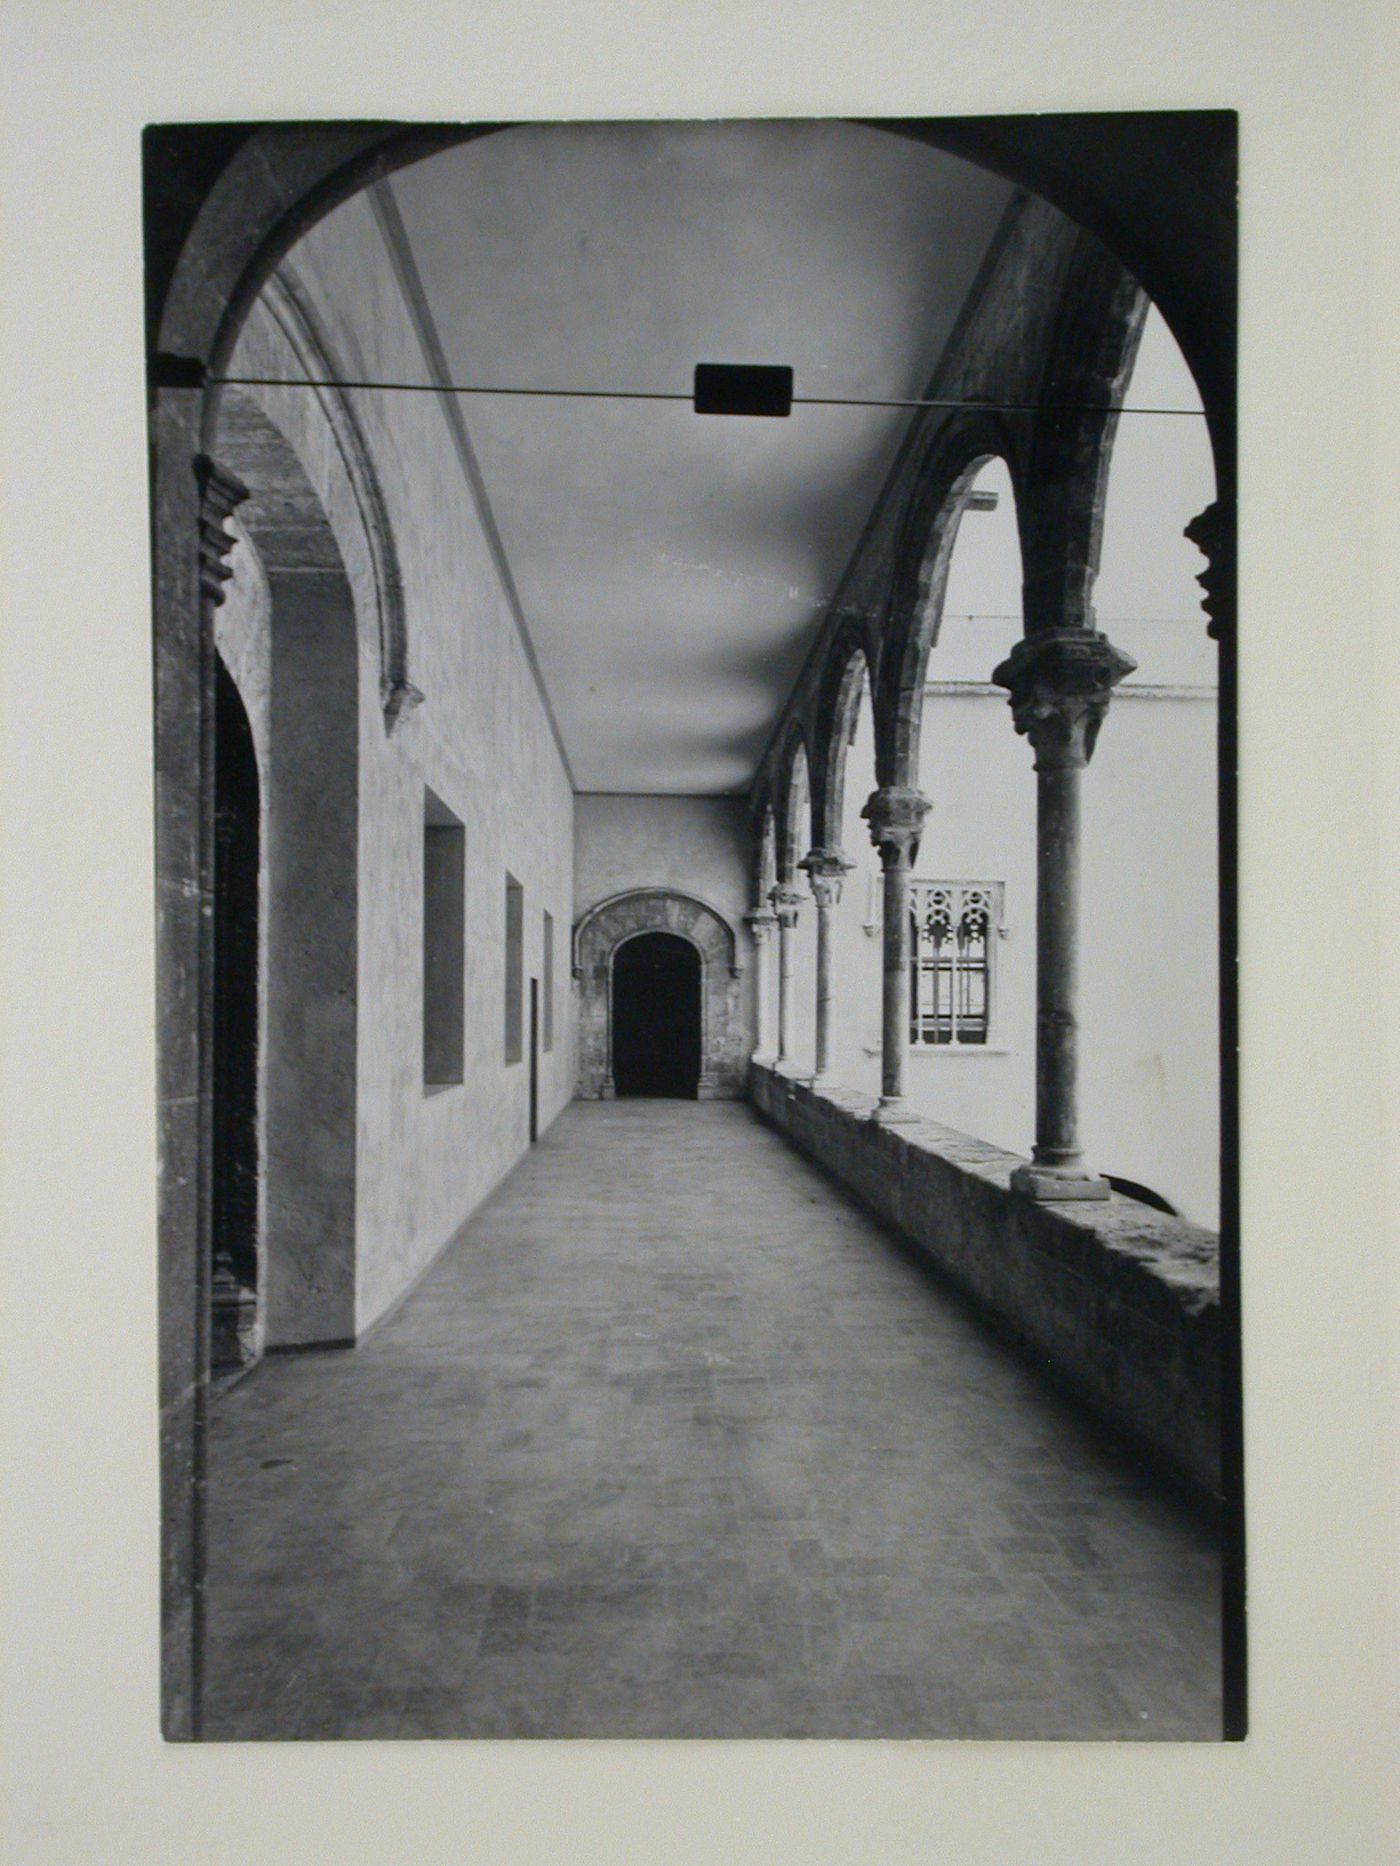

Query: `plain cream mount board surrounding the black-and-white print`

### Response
(4, 0, 1400, 1866)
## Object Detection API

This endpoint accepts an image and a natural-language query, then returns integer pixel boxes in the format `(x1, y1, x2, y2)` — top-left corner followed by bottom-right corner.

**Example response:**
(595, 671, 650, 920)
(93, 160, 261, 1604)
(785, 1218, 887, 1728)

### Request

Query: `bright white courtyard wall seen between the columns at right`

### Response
(914, 620, 1219, 1226)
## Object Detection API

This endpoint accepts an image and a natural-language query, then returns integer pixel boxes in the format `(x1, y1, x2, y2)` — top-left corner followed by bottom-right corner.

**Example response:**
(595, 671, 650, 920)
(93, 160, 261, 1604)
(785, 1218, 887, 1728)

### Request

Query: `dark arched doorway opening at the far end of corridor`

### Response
(612, 933, 700, 1101)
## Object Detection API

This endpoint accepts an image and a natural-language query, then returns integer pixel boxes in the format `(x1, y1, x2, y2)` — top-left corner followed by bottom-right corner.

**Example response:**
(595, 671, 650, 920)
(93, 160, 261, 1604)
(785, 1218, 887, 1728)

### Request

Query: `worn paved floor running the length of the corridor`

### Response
(205, 1101, 1219, 1737)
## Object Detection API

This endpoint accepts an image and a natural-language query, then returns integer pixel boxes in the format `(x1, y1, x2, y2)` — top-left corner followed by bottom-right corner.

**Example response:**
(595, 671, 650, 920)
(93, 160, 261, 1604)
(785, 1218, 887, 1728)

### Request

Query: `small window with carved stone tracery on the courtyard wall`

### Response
(909, 881, 1001, 1049)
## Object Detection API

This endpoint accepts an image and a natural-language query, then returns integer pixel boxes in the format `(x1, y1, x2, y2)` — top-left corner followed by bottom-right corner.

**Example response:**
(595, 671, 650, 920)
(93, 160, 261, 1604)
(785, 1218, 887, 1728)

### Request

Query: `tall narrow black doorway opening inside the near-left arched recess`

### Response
(209, 661, 259, 1372)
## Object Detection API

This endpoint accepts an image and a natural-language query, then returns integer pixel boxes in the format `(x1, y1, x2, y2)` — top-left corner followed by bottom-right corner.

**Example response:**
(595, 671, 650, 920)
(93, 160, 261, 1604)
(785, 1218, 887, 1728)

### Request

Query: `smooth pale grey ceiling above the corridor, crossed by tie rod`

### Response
(385, 121, 1010, 793)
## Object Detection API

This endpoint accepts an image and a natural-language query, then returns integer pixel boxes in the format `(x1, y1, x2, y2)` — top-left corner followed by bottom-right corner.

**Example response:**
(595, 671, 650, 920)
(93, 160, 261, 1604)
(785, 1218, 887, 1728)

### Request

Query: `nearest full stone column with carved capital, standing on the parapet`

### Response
(991, 629, 1137, 1200)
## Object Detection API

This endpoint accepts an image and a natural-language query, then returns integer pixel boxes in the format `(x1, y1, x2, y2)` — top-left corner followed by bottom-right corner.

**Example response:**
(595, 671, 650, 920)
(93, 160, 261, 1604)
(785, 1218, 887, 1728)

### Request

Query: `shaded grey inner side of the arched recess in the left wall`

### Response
(215, 382, 360, 1347)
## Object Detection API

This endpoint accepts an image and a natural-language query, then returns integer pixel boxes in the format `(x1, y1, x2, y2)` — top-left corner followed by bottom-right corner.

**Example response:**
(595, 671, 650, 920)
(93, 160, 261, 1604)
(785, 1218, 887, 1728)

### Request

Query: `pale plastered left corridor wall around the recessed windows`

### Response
(231, 196, 573, 1332)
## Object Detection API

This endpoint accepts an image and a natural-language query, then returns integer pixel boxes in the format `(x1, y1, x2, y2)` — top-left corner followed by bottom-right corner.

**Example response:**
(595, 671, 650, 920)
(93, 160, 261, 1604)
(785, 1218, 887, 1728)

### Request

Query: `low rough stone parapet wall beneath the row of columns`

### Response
(750, 1064, 1221, 1497)
